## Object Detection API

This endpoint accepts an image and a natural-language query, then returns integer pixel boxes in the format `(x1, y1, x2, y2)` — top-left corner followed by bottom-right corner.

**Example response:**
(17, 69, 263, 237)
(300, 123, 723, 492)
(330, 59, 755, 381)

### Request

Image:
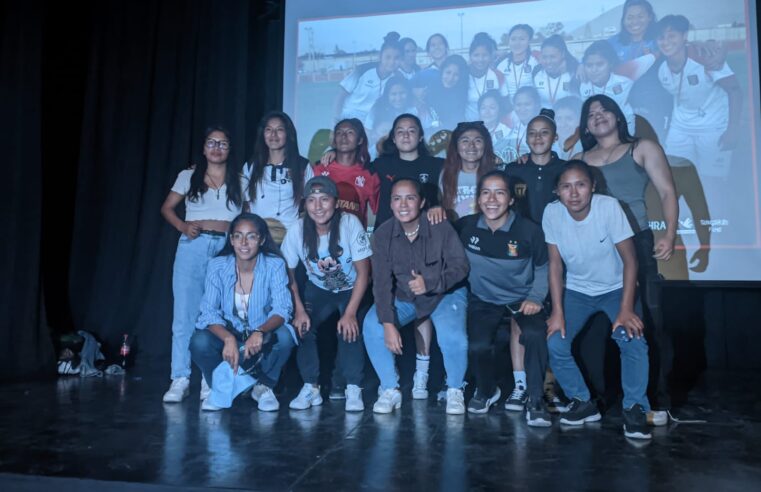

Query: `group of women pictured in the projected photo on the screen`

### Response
(335, 0, 741, 178)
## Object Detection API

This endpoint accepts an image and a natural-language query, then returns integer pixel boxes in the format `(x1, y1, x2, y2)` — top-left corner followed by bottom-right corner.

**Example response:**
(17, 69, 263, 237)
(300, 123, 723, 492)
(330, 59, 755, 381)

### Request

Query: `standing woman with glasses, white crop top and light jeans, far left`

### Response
(161, 127, 243, 403)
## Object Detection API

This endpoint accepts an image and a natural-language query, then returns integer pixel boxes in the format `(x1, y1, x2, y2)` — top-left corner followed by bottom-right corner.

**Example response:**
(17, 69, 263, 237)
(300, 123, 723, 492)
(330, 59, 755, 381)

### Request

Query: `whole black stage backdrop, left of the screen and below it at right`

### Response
(0, 0, 761, 379)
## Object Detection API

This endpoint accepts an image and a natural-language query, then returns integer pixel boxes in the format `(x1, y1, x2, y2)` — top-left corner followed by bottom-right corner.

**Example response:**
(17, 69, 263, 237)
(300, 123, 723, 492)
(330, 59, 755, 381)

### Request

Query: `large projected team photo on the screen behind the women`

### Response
(285, 0, 761, 279)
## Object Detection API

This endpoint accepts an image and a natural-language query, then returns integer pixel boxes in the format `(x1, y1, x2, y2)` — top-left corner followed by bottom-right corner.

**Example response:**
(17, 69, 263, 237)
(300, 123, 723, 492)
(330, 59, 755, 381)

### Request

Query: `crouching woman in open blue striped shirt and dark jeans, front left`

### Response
(190, 213, 296, 412)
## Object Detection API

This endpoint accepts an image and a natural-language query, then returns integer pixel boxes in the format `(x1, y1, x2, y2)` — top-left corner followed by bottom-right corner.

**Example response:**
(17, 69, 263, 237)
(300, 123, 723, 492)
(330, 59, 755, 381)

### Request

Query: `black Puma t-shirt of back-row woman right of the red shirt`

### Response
(370, 155, 444, 229)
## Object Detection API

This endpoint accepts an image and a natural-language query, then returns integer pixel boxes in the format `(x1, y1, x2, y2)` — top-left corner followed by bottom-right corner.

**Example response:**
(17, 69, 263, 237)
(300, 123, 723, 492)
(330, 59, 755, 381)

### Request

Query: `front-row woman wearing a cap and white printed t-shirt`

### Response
(282, 176, 372, 412)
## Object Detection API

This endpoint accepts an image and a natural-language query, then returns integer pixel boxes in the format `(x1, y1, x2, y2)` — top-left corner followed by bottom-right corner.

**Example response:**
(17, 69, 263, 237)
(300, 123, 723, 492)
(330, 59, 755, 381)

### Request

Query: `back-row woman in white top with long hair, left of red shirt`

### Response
(243, 111, 312, 244)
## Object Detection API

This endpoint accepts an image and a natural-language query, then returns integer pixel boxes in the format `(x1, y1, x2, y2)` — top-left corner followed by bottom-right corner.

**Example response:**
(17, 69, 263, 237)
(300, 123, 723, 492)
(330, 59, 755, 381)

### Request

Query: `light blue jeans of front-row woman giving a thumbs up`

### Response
(362, 287, 468, 390)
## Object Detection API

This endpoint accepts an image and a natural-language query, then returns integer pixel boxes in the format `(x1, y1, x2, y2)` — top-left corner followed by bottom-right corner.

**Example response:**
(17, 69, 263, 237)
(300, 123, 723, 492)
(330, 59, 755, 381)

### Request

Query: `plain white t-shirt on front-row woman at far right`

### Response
(542, 194, 634, 296)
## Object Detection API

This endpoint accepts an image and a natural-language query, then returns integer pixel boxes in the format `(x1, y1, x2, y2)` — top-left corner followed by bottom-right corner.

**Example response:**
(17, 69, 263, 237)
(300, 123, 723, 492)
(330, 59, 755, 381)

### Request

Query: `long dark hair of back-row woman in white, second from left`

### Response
(243, 111, 307, 206)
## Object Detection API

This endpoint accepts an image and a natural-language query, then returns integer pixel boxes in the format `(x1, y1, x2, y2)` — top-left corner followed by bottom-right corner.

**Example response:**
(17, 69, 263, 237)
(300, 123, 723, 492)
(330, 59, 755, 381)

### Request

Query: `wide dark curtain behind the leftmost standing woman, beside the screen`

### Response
(61, 1, 282, 367)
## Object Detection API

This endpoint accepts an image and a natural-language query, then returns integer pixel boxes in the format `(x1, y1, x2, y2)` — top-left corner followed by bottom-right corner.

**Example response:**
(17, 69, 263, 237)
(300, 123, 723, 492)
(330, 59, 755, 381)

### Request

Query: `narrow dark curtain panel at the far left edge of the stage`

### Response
(0, 2, 54, 380)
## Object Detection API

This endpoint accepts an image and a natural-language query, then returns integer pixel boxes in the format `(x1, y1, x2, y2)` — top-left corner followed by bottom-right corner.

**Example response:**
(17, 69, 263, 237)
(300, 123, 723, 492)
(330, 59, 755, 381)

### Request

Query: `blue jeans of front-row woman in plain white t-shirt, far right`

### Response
(547, 289, 650, 412)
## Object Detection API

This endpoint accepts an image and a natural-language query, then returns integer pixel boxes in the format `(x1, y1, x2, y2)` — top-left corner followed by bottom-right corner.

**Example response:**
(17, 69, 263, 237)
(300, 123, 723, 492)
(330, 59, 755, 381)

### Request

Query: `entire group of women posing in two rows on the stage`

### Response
(162, 79, 677, 444)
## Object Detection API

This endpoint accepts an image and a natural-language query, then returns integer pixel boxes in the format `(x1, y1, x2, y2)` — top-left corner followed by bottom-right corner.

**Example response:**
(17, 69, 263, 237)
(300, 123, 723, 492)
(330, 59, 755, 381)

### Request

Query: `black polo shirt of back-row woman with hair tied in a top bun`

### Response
(505, 152, 566, 225)
